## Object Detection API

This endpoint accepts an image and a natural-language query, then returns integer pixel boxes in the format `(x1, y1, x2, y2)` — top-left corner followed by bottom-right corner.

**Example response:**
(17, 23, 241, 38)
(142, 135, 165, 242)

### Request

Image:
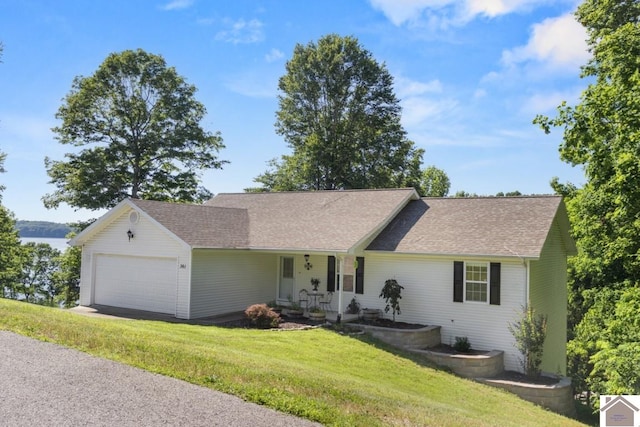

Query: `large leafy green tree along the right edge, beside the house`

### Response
(535, 0, 640, 400)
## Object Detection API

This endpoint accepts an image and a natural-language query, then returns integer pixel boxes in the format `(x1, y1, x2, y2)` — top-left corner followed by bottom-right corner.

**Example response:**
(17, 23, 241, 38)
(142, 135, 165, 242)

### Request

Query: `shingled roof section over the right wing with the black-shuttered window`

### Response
(367, 196, 574, 258)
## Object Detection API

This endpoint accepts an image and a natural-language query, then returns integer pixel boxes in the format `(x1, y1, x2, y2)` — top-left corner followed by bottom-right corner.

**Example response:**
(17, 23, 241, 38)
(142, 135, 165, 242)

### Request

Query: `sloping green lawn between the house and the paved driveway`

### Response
(0, 299, 580, 426)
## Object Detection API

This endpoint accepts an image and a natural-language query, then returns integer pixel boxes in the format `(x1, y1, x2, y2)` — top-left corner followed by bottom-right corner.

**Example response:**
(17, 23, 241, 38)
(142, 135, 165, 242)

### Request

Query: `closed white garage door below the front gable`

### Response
(94, 255, 178, 314)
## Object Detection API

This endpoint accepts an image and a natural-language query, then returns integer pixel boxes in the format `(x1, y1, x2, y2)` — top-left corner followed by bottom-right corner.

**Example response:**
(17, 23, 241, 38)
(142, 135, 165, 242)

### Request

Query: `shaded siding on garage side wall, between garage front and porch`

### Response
(191, 249, 279, 318)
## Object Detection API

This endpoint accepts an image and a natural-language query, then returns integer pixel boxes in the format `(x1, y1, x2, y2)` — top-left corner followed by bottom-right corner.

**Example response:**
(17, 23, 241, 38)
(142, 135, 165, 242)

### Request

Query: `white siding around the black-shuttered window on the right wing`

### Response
(362, 253, 526, 371)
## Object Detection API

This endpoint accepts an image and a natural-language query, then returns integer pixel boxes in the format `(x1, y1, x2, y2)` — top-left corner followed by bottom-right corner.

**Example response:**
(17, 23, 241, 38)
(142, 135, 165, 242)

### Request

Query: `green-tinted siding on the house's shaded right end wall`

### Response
(529, 221, 567, 374)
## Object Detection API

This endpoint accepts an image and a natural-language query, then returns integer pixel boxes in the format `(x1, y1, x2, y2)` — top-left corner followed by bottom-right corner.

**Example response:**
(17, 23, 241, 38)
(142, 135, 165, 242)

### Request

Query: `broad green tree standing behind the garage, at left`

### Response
(43, 49, 226, 209)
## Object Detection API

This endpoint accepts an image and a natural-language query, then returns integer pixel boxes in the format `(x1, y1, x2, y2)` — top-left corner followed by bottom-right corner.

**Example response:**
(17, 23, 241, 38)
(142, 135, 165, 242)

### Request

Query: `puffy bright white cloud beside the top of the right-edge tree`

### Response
(502, 14, 590, 71)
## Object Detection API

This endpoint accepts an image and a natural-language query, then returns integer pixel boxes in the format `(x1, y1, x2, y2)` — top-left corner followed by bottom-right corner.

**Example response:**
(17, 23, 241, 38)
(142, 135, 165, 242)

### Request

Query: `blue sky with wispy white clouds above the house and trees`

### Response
(0, 0, 589, 222)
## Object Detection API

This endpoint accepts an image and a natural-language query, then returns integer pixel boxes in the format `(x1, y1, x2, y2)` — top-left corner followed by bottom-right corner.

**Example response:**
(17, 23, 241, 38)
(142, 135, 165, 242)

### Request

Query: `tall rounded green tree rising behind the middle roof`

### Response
(255, 34, 423, 191)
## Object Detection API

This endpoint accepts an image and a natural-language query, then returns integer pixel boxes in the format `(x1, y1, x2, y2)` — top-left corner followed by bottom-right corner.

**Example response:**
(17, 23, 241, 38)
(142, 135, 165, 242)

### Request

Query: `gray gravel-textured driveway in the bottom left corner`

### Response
(0, 331, 319, 427)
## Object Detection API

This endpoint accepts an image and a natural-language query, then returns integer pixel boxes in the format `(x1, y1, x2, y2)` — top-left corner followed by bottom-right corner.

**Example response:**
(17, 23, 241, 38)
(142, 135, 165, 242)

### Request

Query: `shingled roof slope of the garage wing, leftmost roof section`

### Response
(130, 199, 249, 248)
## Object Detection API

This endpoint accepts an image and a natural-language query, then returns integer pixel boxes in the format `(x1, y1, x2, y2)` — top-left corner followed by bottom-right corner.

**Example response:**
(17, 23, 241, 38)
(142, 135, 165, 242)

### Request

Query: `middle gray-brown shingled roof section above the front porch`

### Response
(205, 189, 417, 251)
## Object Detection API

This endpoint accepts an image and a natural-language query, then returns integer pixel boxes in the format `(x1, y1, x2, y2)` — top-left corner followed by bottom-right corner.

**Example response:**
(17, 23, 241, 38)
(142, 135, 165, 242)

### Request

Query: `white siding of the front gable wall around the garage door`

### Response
(80, 209, 191, 318)
